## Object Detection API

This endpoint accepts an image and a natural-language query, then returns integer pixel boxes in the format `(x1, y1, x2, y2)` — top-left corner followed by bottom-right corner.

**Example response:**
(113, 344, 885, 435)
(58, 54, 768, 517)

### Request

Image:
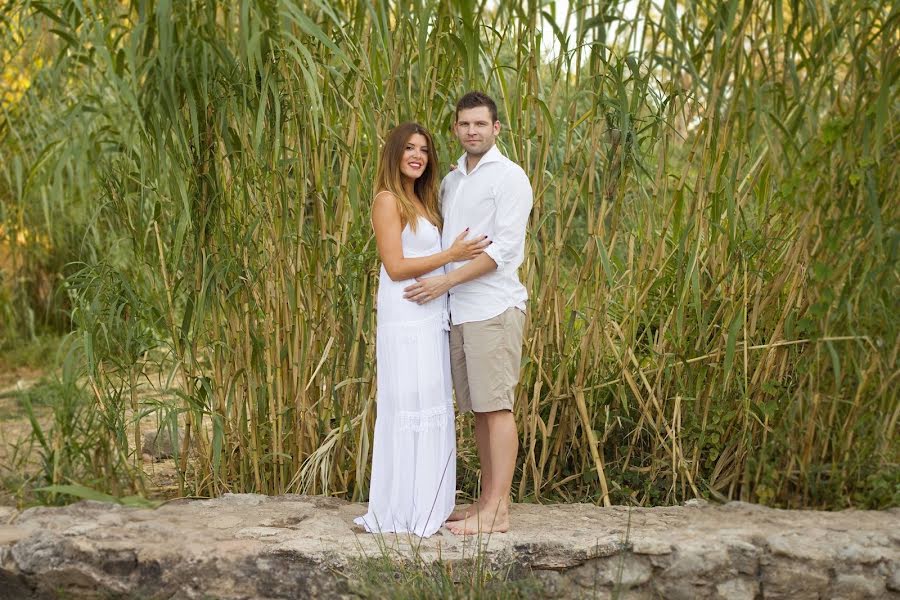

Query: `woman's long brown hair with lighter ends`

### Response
(375, 123, 443, 231)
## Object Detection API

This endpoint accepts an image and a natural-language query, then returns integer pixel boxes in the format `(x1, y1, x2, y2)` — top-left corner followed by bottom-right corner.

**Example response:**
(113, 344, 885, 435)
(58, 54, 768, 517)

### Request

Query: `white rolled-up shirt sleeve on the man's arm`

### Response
(484, 168, 533, 270)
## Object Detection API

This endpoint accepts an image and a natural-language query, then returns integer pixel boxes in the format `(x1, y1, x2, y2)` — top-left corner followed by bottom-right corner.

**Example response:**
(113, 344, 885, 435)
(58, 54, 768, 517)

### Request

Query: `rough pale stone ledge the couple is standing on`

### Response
(0, 494, 900, 600)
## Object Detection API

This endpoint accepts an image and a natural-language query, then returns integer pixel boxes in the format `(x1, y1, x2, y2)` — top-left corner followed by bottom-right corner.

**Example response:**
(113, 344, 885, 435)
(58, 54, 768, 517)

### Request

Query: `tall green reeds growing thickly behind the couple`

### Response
(0, 0, 900, 508)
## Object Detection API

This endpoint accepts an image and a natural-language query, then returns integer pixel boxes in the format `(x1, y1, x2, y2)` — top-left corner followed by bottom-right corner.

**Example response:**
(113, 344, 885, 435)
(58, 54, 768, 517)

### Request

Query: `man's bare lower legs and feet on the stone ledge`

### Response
(447, 410, 519, 535)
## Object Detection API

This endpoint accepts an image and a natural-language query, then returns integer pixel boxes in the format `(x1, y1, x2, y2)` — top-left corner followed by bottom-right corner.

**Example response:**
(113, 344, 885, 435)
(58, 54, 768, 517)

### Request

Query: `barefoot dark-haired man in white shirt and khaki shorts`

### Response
(405, 92, 532, 535)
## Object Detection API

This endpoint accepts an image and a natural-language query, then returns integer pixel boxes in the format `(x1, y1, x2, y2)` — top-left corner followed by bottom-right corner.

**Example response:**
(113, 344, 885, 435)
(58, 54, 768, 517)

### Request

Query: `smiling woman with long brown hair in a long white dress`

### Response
(356, 123, 489, 537)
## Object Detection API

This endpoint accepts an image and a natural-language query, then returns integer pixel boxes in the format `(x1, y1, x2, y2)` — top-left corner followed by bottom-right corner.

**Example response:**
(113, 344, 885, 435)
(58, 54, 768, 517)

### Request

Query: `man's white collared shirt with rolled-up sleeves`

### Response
(440, 146, 532, 325)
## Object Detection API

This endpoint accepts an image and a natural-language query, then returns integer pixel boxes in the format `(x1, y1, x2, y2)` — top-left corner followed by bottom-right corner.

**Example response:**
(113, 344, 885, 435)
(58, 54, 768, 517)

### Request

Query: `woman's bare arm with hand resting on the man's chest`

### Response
(372, 191, 490, 281)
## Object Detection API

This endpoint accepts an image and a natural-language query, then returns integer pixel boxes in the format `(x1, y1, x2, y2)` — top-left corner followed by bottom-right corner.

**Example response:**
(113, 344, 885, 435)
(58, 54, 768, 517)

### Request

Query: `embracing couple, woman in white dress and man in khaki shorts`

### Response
(356, 92, 532, 537)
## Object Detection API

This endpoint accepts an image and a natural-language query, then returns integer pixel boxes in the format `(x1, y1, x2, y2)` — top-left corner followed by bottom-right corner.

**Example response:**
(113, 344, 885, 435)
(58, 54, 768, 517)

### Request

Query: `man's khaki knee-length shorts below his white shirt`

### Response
(450, 308, 525, 412)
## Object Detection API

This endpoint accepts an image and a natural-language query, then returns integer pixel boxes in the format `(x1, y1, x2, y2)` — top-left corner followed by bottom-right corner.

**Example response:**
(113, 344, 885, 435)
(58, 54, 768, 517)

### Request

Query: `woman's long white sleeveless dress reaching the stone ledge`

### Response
(355, 217, 456, 537)
